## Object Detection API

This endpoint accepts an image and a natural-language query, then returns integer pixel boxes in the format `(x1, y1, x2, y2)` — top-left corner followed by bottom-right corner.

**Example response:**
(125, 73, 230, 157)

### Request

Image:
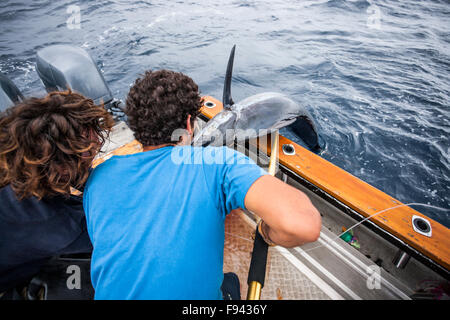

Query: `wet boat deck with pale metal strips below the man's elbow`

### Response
(224, 211, 412, 300)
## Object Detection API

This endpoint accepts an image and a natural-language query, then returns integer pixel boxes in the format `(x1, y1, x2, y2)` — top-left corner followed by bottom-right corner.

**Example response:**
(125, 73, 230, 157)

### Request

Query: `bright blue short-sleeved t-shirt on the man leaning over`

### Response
(83, 146, 265, 300)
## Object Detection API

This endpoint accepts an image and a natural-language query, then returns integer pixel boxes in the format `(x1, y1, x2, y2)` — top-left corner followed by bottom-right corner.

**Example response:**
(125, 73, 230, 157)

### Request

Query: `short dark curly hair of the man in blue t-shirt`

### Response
(125, 70, 202, 146)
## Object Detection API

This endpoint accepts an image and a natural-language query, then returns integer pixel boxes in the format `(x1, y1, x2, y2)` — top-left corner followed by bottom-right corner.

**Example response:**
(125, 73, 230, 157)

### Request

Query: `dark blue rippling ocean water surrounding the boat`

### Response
(0, 0, 450, 227)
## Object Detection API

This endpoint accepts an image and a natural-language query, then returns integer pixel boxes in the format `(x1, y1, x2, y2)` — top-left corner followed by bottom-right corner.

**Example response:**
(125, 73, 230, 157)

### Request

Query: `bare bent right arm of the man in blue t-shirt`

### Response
(245, 175, 322, 248)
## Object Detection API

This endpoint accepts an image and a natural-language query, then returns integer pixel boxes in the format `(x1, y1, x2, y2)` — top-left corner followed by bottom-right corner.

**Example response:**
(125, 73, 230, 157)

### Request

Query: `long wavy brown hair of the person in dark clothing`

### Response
(0, 90, 114, 199)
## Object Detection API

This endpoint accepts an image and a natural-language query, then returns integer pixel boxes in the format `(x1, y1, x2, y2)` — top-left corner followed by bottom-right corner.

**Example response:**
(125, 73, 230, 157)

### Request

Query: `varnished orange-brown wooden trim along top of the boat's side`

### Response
(201, 96, 450, 271)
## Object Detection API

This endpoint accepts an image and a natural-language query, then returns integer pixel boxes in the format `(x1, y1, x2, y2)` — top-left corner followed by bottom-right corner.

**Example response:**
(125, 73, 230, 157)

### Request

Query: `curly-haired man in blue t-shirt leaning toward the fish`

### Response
(83, 70, 321, 299)
